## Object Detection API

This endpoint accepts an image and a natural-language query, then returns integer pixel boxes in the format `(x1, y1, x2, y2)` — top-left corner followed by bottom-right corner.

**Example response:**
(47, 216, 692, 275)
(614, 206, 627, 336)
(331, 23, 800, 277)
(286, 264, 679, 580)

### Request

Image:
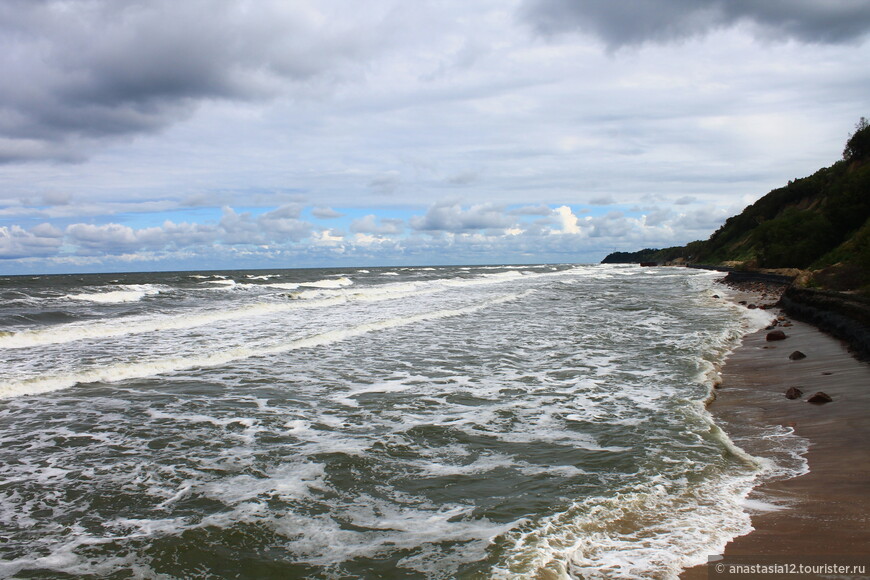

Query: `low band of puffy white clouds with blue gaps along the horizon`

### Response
(0, 201, 748, 270)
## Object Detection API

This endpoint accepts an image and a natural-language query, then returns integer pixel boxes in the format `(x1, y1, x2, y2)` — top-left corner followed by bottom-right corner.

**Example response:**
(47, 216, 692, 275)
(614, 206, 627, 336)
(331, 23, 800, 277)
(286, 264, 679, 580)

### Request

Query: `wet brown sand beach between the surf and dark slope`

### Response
(680, 284, 870, 580)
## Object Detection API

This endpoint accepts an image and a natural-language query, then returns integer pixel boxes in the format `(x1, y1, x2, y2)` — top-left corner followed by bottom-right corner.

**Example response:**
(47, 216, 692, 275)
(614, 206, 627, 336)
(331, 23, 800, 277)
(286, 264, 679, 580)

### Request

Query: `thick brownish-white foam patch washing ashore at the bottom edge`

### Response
(494, 466, 755, 579)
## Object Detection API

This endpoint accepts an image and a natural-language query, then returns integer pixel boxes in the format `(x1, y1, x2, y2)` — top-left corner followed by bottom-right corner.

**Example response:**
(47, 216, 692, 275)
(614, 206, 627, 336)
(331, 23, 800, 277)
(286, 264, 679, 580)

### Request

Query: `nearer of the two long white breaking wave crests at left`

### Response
(0, 291, 532, 398)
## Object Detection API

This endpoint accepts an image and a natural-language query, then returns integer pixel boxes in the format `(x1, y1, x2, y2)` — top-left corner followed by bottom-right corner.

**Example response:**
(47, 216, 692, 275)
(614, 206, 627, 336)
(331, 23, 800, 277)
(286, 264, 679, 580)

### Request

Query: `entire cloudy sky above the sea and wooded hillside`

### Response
(0, 0, 870, 275)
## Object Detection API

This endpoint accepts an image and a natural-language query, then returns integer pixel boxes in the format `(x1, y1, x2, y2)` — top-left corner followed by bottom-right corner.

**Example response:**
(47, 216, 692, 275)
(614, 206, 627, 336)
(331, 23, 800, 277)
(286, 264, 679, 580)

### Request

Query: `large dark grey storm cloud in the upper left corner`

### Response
(0, 0, 382, 162)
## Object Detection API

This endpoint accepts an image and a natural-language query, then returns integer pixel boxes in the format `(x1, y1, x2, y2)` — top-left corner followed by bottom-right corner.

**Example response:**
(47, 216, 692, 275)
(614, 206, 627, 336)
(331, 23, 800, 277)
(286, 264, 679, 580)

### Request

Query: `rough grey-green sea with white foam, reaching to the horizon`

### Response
(0, 264, 806, 579)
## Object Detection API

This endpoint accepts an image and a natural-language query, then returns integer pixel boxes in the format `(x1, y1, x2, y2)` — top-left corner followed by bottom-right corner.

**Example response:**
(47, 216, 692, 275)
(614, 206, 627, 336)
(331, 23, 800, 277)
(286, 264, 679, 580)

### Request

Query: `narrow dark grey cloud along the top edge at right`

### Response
(522, 0, 870, 48)
